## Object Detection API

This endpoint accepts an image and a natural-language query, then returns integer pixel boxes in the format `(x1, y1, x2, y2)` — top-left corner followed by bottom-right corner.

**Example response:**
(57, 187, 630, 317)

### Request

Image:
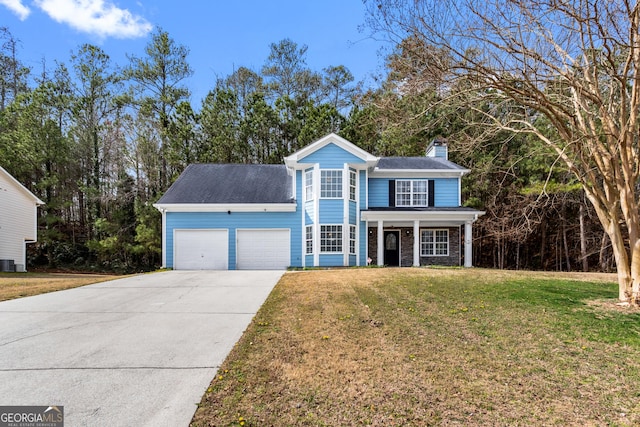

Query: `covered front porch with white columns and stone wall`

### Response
(362, 208, 483, 267)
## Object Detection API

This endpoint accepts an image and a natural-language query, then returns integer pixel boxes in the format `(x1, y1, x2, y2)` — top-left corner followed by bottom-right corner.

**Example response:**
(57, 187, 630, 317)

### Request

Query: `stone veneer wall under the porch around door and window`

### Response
(368, 227, 462, 267)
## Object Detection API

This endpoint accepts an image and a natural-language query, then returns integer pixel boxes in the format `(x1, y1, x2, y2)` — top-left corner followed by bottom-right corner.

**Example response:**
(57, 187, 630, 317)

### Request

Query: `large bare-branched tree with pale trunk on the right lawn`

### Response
(367, 0, 640, 306)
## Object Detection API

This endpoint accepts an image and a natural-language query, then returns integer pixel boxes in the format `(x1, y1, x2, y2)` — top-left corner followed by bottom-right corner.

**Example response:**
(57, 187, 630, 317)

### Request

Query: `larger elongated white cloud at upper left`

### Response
(35, 0, 152, 39)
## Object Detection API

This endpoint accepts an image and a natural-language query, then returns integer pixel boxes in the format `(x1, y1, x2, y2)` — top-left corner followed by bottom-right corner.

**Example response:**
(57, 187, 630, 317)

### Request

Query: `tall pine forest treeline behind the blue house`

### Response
(0, 28, 615, 272)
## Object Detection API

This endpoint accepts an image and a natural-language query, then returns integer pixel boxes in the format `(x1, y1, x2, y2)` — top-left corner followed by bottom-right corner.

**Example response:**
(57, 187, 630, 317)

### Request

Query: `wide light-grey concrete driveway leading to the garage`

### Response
(0, 271, 283, 427)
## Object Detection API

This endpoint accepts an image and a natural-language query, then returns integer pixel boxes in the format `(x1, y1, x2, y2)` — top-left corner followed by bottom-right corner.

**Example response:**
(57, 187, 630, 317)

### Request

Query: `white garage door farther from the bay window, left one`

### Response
(173, 230, 229, 270)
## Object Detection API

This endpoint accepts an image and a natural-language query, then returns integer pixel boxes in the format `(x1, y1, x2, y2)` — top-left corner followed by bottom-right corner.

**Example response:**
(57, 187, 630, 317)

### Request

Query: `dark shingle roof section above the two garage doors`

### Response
(158, 164, 293, 204)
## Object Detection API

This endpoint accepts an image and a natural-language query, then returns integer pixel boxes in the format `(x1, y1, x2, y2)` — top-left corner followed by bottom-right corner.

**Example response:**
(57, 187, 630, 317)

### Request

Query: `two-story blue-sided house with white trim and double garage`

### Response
(154, 134, 484, 270)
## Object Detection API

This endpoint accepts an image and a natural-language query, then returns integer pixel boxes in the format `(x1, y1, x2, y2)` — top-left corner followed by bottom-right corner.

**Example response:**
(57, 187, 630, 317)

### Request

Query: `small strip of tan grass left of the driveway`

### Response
(0, 273, 116, 301)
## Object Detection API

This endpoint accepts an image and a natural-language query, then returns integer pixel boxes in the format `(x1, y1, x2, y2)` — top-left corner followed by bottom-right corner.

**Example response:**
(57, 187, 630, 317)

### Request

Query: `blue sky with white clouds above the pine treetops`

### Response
(0, 0, 384, 103)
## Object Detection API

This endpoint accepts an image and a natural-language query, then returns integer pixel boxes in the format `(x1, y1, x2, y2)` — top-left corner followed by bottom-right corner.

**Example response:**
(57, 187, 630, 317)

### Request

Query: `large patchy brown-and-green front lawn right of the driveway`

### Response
(192, 268, 640, 426)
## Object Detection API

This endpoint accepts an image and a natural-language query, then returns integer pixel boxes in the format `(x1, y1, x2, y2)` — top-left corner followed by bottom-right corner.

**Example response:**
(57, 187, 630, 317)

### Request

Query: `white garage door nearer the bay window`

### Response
(237, 229, 291, 270)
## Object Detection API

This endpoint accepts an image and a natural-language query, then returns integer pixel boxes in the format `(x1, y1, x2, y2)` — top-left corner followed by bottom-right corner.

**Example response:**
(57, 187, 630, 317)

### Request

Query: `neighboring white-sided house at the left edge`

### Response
(0, 166, 44, 272)
